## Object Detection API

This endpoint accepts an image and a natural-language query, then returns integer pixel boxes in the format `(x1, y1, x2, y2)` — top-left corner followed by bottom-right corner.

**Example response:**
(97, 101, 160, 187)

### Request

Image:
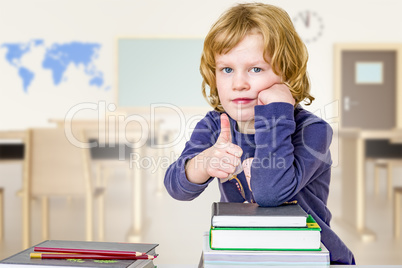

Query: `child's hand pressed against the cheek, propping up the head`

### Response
(258, 84, 295, 105)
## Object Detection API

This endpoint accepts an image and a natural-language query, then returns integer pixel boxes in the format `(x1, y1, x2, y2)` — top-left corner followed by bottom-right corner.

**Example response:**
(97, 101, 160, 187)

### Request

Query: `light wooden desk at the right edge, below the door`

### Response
(339, 129, 402, 241)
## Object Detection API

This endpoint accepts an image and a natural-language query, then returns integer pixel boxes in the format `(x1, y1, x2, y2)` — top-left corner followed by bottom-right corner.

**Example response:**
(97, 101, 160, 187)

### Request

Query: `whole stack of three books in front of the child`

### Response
(202, 202, 329, 268)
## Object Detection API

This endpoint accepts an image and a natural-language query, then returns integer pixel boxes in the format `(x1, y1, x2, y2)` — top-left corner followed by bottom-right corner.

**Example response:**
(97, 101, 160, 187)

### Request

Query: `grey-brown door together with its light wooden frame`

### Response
(334, 43, 402, 131)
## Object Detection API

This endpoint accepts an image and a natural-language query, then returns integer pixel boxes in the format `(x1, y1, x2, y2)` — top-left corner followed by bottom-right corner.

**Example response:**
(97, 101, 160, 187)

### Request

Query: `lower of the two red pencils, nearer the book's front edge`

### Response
(30, 253, 156, 260)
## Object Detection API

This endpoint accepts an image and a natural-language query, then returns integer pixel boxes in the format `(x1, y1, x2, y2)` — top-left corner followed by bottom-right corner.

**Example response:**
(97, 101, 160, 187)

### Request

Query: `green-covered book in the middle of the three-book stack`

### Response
(210, 216, 321, 250)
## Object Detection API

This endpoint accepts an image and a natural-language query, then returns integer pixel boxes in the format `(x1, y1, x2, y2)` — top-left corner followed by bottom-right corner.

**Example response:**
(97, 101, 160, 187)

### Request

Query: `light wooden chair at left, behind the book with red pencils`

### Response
(20, 128, 104, 248)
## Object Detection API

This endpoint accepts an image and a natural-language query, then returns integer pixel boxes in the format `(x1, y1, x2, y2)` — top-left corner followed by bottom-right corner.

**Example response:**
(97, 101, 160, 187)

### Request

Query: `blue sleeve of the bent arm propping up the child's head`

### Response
(251, 103, 332, 206)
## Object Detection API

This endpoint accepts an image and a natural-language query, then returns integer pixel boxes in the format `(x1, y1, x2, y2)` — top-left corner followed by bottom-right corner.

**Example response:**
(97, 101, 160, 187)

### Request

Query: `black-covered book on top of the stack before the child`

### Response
(211, 202, 308, 227)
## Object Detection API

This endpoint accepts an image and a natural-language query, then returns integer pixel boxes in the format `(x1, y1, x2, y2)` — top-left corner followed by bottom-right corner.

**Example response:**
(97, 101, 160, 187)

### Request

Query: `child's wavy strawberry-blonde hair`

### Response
(200, 3, 314, 112)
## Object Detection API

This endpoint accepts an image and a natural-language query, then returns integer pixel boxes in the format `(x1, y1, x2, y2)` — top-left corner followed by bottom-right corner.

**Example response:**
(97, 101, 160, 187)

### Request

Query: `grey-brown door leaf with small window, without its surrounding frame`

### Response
(341, 50, 397, 130)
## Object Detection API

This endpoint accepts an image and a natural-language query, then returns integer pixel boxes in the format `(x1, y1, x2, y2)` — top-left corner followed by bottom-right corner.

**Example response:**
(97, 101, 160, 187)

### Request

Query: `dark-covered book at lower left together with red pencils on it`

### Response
(0, 240, 158, 268)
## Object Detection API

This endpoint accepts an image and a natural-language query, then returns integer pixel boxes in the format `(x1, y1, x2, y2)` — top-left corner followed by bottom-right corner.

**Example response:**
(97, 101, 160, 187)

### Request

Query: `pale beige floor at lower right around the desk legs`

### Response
(329, 164, 402, 265)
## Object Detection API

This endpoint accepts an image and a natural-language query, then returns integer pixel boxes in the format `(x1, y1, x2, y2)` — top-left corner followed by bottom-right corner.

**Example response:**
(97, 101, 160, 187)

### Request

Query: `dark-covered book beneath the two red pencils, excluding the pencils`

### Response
(0, 240, 158, 268)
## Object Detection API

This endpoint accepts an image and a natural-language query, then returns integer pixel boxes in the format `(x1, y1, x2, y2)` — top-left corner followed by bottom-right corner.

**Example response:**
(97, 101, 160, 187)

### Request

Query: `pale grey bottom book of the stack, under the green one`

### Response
(200, 232, 330, 268)
